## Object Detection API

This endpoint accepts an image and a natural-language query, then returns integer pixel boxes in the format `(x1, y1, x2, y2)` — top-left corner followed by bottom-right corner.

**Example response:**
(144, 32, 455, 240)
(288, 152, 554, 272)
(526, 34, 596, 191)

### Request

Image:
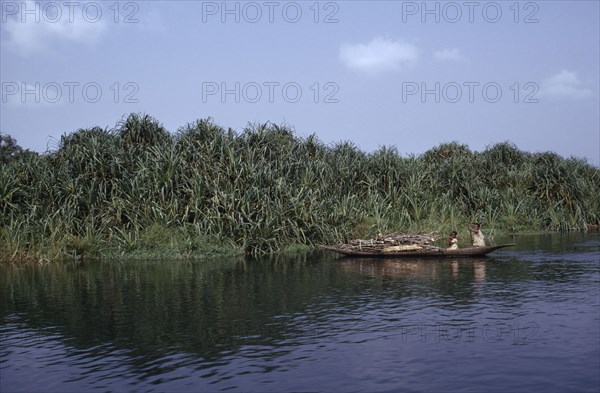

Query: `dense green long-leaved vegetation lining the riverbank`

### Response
(0, 114, 600, 260)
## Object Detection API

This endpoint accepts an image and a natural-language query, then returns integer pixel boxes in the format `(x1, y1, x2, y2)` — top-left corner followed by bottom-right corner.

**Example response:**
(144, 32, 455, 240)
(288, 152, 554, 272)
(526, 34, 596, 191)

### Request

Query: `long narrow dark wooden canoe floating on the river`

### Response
(321, 244, 514, 258)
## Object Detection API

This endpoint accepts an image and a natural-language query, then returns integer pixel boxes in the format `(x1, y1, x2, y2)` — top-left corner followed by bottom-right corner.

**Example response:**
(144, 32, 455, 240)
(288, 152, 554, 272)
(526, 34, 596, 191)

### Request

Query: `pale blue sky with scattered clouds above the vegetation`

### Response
(0, 0, 600, 166)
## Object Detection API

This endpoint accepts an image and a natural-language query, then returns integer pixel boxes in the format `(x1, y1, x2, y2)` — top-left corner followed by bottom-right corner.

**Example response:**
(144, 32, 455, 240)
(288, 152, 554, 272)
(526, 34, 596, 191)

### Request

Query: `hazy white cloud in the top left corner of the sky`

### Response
(2, 1, 106, 55)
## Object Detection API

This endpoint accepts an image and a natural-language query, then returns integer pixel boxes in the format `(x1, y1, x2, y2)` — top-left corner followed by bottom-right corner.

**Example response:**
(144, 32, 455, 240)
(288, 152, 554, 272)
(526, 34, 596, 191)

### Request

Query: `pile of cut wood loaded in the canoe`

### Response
(340, 233, 437, 252)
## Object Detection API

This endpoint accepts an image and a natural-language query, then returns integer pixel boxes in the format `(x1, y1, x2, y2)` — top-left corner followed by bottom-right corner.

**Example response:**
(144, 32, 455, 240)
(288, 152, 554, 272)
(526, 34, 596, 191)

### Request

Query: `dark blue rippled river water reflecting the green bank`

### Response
(0, 234, 600, 392)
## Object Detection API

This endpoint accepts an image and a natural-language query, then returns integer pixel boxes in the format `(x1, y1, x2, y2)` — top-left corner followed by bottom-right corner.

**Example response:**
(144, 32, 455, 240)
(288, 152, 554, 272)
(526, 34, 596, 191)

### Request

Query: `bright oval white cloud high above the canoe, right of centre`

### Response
(339, 37, 419, 74)
